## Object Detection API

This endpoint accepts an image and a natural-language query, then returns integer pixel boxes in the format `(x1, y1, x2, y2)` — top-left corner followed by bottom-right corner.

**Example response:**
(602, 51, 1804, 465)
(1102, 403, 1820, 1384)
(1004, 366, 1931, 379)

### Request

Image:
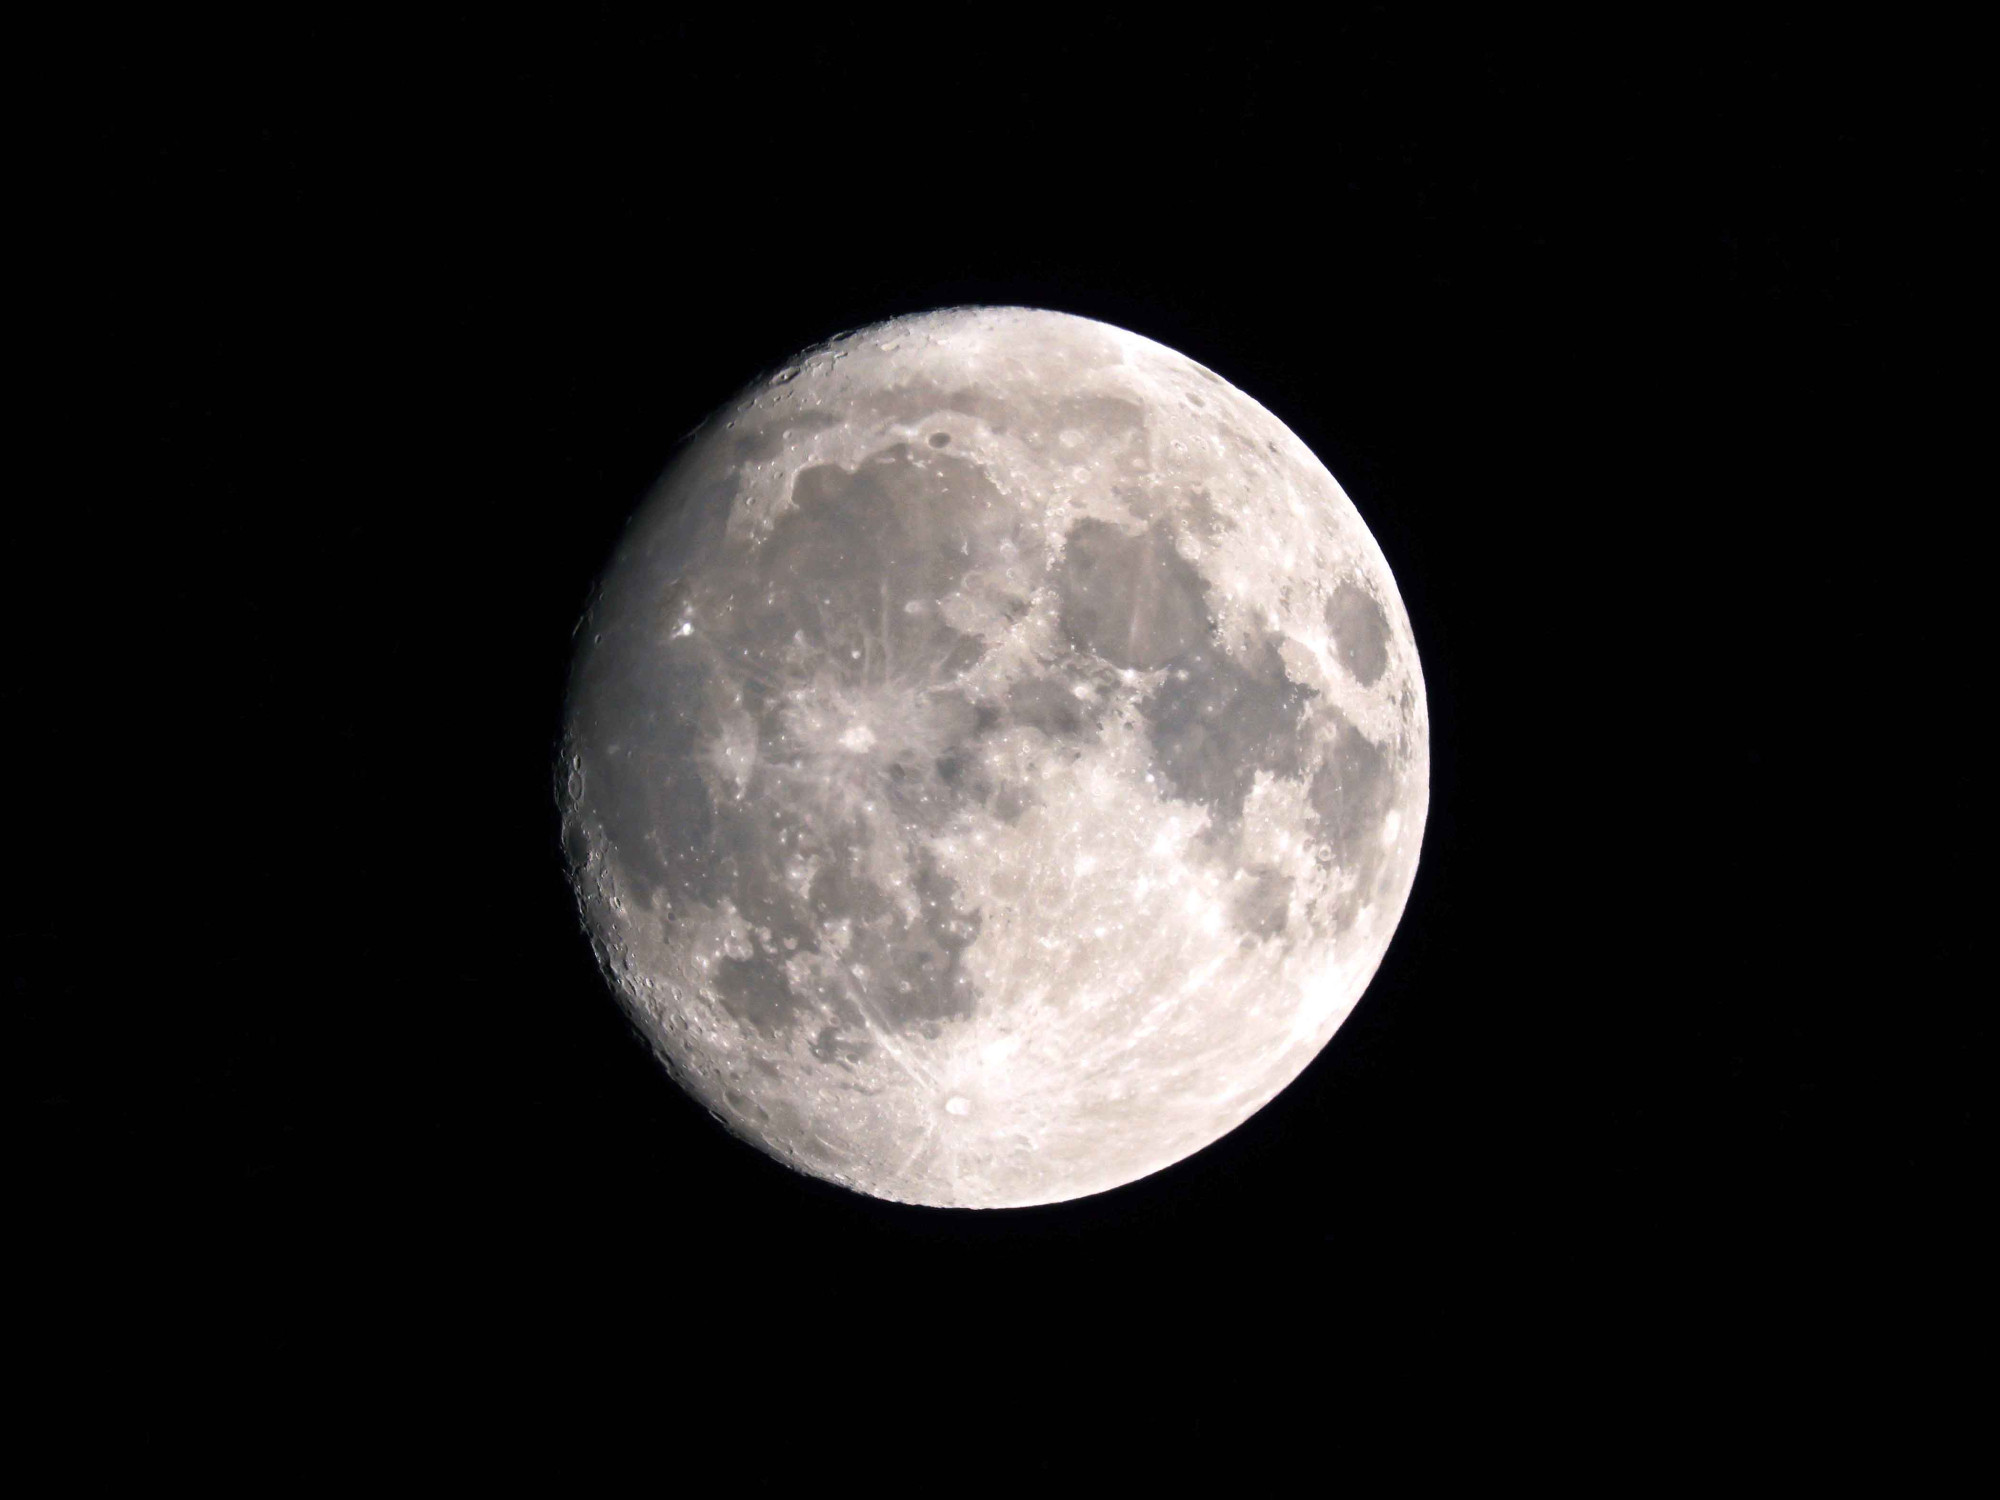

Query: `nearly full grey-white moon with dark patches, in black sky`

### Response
(558, 308, 1430, 1208)
